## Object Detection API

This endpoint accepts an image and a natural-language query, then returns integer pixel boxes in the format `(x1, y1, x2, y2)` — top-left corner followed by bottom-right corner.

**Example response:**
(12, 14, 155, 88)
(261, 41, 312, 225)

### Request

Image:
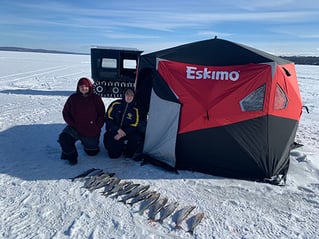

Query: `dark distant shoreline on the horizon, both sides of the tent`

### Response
(0, 47, 319, 65)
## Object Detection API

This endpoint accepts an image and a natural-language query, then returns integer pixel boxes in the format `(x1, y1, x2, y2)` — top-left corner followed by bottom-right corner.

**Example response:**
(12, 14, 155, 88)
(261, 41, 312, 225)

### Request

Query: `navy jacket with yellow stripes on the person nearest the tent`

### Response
(105, 99, 139, 134)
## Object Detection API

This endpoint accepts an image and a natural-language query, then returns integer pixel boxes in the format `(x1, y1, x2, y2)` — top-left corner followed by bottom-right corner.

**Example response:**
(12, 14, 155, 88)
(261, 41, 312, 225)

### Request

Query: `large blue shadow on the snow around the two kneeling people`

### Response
(0, 124, 218, 180)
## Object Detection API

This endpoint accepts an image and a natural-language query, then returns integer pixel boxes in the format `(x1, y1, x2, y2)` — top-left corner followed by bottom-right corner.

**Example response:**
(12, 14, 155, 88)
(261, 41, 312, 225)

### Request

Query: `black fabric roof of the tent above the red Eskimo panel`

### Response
(140, 39, 289, 68)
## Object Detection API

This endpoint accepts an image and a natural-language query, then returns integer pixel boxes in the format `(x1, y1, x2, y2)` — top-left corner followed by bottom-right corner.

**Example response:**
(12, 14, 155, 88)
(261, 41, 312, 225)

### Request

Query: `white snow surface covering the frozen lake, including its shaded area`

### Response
(0, 52, 319, 239)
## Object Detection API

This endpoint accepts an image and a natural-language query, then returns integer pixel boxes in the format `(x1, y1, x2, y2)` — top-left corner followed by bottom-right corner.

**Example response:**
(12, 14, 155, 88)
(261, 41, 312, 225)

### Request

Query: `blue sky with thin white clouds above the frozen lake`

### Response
(0, 0, 319, 56)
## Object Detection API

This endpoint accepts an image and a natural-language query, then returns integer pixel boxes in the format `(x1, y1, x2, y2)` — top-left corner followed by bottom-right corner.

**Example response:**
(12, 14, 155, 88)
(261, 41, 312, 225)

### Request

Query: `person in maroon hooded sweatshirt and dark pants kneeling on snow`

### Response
(58, 77, 105, 165)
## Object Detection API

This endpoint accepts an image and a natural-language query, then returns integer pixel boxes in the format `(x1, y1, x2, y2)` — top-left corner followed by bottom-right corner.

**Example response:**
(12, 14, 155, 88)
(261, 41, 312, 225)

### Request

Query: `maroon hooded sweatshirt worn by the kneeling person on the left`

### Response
(62, 78, 105, 138)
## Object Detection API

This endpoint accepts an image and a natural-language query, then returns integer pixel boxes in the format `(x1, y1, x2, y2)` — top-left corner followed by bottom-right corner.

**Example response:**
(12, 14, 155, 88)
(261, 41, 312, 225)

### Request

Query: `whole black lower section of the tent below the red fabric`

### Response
(176, 116, 298, 181)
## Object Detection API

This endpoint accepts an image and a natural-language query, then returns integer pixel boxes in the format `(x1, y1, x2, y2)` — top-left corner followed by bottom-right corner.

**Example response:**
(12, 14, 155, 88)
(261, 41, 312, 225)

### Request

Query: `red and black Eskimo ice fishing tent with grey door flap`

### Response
(136, 38, 302, 183)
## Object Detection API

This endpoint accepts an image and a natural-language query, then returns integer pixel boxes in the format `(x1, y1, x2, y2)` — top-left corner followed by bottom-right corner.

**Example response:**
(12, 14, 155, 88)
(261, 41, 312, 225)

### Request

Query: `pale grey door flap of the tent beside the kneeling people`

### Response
(143, 90, 180, 167)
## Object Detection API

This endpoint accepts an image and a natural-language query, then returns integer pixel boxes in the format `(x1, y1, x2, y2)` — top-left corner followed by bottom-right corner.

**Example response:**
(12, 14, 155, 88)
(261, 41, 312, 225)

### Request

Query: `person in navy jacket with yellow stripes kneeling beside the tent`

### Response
(103, 88, 140, 158)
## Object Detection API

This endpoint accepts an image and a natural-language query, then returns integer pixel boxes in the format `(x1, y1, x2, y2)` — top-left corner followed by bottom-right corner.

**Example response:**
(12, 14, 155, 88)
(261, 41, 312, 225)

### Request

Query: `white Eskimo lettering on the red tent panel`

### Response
(186, 66, 239, 81)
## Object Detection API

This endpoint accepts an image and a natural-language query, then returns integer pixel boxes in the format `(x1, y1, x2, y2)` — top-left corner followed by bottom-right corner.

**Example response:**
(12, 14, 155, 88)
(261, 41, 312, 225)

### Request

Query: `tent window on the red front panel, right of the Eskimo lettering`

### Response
(240, 84, 266, 112)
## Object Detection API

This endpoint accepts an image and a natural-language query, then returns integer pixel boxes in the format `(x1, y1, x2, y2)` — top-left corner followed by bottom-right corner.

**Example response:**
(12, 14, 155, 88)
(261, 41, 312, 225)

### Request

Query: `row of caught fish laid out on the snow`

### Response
(71, 168, 204, 234)
